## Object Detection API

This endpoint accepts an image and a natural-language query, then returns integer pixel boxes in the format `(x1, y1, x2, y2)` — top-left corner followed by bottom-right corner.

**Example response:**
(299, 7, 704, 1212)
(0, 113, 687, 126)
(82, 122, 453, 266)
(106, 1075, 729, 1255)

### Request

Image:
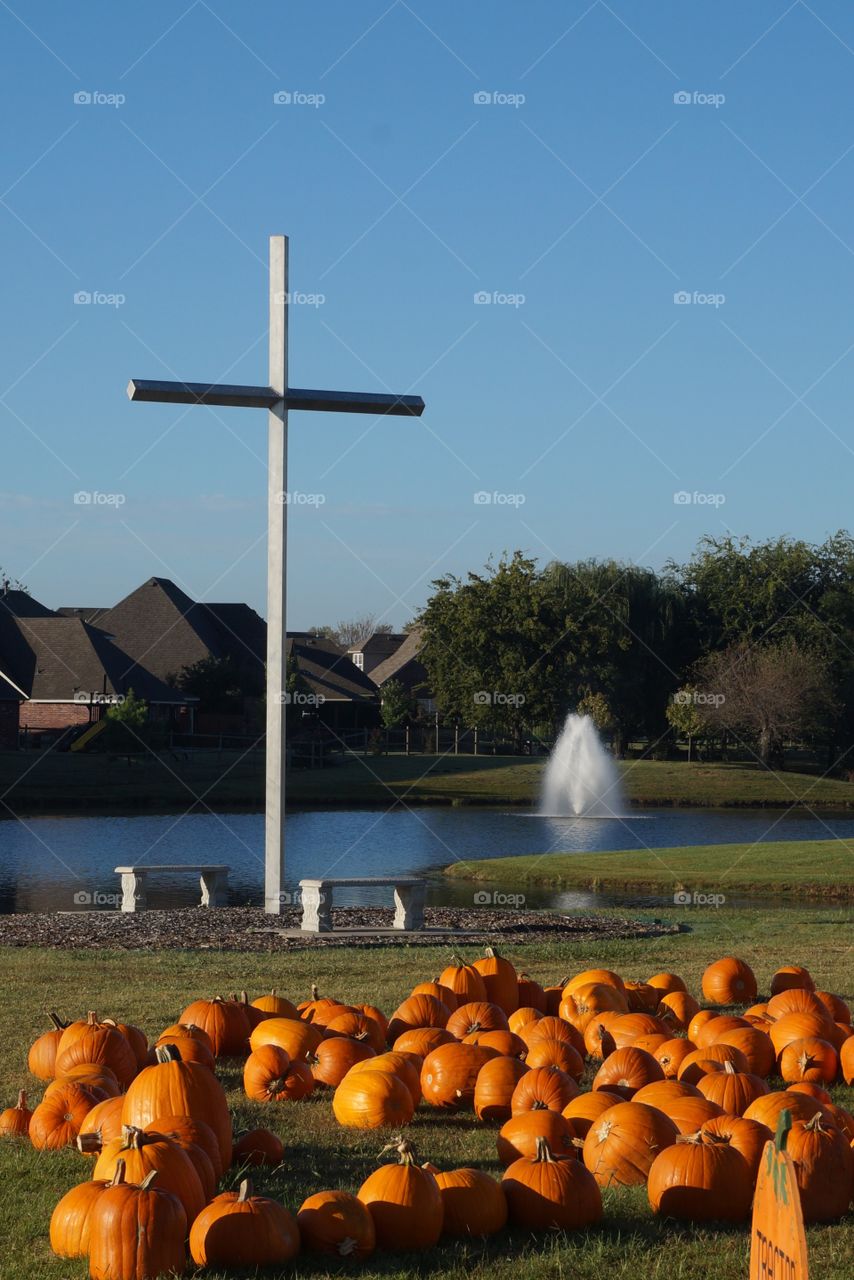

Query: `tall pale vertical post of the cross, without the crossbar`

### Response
(264, 236, 288, 915)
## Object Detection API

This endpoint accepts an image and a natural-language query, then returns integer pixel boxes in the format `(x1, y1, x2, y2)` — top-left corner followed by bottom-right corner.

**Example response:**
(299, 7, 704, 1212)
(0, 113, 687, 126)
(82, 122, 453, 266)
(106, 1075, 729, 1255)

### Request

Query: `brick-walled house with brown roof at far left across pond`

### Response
(0, 591, 188, 746)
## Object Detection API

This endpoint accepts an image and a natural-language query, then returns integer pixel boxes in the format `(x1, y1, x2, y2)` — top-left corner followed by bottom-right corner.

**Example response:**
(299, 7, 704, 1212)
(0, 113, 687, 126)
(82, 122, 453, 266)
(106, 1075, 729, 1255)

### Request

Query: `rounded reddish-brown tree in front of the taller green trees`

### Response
(698, 640, 834, 768)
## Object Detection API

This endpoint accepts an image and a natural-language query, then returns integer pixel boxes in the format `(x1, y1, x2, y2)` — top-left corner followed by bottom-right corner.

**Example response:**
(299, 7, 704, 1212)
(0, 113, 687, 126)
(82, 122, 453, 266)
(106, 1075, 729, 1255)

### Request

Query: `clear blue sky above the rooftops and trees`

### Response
(0, 0, 854, 627)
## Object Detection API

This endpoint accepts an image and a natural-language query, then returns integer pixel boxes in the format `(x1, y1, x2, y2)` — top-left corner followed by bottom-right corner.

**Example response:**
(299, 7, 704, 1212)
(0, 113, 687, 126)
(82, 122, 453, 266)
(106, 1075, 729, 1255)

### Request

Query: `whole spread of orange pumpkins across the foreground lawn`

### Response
(0, 948, 854, 1280)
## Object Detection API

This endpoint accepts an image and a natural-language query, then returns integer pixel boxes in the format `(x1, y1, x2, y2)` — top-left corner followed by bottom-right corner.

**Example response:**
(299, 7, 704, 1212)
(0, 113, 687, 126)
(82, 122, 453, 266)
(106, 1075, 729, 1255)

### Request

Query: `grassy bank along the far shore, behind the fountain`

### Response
(0, 750, 854, 813)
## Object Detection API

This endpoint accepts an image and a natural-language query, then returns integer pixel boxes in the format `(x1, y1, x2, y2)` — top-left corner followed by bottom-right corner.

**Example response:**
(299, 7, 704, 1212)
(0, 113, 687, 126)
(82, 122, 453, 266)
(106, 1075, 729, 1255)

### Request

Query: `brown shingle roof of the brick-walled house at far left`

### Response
(0, 617, 186, 703)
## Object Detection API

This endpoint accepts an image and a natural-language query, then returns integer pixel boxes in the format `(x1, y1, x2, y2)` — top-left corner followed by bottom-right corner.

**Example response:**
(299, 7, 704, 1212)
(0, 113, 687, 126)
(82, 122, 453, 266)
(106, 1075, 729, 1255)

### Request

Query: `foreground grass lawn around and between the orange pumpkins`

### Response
(0, 906, 854, 1280)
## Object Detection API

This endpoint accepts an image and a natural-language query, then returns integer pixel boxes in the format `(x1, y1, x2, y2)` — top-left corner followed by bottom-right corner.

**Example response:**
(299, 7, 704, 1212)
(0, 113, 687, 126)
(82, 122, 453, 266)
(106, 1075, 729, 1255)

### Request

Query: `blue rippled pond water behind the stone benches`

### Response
(0, 808, 854, 913)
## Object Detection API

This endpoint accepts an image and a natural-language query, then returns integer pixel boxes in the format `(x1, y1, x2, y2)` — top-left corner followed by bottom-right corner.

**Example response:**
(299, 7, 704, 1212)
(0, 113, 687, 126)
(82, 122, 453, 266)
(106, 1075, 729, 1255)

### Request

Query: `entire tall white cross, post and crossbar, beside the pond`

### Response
(128, 236, 424, 914)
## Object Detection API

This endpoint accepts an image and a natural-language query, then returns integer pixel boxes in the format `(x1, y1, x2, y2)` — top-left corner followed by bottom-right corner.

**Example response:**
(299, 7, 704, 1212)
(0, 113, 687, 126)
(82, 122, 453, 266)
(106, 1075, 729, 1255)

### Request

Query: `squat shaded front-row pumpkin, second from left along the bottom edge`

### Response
(189, 1179, 300, 1270)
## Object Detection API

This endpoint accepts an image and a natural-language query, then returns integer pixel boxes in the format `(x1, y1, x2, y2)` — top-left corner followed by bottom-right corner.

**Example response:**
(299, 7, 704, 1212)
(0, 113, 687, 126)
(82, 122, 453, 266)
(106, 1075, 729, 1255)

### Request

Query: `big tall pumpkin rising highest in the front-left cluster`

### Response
(122, 1044, 231, 1169)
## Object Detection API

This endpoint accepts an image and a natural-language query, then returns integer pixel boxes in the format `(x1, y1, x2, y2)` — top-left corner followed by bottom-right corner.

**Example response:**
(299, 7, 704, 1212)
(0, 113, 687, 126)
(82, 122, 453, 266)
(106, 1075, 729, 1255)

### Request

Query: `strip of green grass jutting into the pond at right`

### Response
(446, 840, 854, 901)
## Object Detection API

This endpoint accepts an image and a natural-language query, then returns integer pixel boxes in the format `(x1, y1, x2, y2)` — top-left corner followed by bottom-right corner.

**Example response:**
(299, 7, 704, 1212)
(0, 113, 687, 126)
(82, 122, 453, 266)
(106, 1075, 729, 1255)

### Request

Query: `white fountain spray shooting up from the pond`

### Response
(539, 712, 627, 818)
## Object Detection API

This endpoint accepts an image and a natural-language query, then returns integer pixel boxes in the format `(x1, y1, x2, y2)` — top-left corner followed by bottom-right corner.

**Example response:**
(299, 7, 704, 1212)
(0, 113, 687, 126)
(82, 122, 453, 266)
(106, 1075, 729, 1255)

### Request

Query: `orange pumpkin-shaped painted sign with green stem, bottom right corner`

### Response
(750, 1111, 809, 1280)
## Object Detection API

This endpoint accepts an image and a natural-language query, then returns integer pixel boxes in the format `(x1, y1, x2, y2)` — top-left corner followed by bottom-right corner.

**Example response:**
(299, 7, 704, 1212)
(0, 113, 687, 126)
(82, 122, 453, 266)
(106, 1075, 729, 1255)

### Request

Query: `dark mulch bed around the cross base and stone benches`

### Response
(0, 906, 679, 951)
